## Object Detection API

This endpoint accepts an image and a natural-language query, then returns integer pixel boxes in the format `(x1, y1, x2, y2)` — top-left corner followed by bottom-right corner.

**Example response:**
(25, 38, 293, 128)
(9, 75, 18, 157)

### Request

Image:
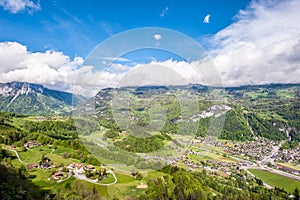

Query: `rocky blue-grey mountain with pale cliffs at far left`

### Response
(0, 82, 85, 115)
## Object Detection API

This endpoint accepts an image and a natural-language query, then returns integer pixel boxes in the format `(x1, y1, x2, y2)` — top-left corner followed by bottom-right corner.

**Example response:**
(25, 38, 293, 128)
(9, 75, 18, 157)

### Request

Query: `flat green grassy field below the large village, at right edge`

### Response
(249, 169, 300, 193)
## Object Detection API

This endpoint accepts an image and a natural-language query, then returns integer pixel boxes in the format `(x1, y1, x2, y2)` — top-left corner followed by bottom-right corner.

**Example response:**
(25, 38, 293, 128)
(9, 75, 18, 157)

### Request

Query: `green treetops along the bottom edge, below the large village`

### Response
(139, 166, 289, 200)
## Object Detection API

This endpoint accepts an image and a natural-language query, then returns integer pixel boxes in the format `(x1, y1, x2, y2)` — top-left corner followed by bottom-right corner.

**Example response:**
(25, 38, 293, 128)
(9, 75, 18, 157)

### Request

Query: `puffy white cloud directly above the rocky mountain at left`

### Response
(0, 42, 83, 90)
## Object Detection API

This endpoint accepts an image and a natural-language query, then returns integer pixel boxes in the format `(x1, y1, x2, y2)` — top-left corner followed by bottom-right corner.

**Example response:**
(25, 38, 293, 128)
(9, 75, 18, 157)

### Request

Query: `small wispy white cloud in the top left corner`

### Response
(0, 0, 41, 14)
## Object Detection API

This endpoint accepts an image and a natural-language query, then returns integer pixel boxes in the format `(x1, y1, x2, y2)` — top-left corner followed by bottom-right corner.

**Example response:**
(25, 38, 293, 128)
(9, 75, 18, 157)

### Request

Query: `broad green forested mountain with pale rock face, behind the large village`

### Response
(90, 84, 300, 141)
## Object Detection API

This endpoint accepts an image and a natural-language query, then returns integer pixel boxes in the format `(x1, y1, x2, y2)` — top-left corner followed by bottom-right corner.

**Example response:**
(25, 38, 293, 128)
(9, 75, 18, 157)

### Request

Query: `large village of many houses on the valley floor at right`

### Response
(142, 138, 300, 179)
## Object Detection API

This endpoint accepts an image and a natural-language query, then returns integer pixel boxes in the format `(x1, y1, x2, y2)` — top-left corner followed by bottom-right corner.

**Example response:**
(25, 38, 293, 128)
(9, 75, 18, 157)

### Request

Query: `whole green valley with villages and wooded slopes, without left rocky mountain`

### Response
(0, 84, 300, 199)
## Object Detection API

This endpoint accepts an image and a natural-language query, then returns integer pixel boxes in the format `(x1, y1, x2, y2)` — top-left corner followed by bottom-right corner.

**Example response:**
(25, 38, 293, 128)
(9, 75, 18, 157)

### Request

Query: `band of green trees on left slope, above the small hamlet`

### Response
(0, 113, 100, 165)
